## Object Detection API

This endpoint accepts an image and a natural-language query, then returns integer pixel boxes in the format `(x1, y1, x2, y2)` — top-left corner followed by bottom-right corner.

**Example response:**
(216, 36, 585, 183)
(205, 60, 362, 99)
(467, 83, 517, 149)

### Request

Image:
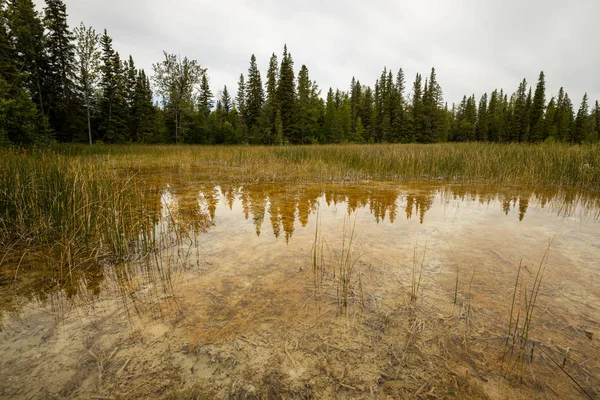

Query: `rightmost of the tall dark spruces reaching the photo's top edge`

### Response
(44, 0, 77, 141)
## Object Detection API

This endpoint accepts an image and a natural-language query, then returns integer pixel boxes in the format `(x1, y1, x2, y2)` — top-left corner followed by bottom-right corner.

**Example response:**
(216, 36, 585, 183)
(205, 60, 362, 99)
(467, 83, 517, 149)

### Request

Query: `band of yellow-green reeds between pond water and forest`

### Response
(50, 143, 600, 190)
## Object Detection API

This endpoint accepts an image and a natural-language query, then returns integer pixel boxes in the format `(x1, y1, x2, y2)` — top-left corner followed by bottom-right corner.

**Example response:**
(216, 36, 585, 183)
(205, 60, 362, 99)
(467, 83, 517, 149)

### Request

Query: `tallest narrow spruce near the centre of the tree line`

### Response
(277, 45, 296, 140)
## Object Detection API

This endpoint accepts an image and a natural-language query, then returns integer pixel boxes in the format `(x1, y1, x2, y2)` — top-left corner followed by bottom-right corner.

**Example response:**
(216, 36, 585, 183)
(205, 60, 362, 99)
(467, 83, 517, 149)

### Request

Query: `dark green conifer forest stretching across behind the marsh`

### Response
(0, 0, 600, 145)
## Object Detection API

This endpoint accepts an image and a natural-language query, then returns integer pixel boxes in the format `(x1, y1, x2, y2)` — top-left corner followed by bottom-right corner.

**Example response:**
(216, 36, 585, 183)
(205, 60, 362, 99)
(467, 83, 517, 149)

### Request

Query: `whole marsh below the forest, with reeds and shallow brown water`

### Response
(0, 145, 600, 399)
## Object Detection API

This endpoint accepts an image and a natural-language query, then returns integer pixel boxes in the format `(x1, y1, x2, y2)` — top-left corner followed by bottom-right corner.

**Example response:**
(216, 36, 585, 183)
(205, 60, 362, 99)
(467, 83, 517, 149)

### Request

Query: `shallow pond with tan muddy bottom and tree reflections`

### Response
(0, 182, 600, 399)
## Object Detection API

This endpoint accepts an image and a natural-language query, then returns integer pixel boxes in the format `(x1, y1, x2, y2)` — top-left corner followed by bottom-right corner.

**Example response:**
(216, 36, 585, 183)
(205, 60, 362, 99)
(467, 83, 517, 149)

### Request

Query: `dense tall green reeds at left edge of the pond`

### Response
(0, 149, 154, 276)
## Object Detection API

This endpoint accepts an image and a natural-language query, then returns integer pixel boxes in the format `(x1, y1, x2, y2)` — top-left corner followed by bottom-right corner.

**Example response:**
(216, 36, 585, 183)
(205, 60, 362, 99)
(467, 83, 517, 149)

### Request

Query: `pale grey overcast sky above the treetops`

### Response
(35, 0, 600, 105)
